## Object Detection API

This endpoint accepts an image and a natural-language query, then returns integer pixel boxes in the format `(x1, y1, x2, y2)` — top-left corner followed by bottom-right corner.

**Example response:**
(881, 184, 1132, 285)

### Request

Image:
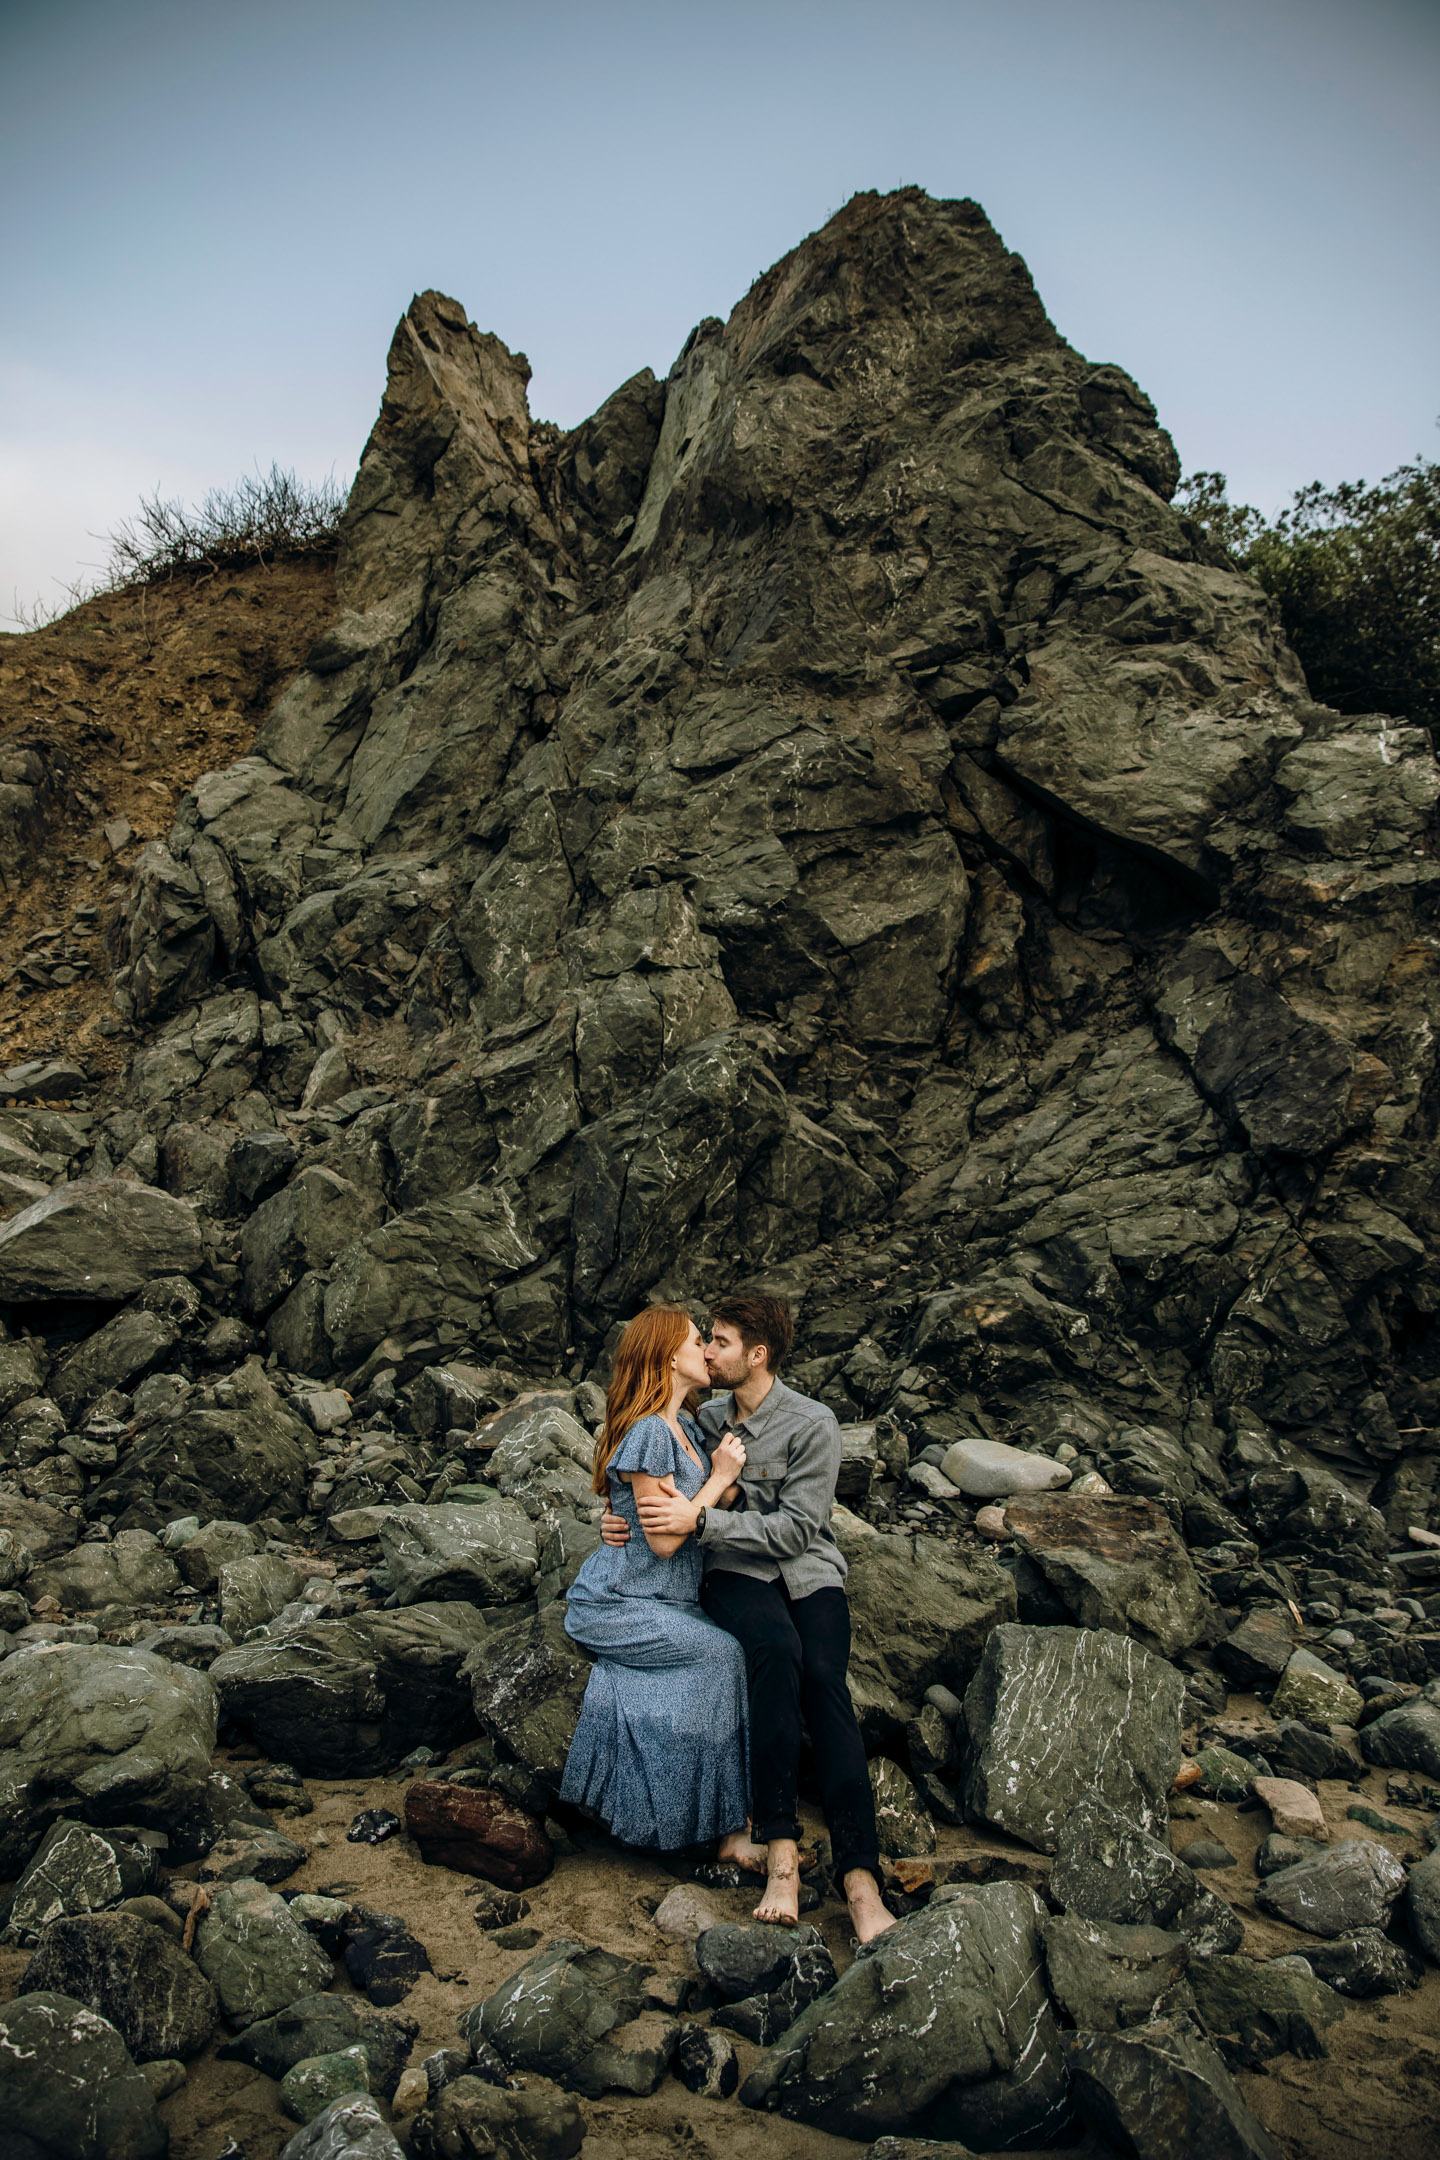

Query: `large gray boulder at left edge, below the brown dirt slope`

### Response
(0, 1177, 205, 1302)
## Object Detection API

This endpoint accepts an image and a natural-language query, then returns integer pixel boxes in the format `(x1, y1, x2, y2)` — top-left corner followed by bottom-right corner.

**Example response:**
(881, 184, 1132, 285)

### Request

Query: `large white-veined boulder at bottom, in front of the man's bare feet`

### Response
(741, 1884, 1069, 2151)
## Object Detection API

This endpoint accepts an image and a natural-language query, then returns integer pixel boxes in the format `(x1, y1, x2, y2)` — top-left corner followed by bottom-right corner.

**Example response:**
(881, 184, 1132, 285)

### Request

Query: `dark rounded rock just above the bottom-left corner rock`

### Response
(19, 1912, 220, 2063)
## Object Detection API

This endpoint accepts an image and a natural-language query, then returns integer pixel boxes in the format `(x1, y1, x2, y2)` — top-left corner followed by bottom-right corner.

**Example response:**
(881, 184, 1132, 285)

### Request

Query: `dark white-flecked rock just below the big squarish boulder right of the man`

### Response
(1049, 1795, 1246, 1955)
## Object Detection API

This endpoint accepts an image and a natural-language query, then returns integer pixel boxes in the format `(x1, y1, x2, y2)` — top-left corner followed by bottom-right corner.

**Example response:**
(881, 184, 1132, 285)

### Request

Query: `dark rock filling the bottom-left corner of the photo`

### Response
(0, 1994, 171, 2160)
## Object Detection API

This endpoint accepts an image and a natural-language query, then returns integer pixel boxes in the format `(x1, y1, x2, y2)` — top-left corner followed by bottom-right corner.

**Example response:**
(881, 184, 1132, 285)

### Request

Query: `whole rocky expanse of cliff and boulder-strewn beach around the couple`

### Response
(0, 190, 1440, 2160)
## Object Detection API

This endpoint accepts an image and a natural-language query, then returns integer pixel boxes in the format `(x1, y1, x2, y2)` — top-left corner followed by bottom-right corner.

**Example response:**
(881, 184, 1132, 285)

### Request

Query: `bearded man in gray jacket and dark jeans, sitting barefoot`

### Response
(604, 1294, 892, 1942)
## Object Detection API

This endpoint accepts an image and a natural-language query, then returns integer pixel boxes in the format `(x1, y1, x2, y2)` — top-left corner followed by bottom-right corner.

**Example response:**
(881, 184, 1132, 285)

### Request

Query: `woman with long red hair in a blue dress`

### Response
(561, 1305, 749, 1851)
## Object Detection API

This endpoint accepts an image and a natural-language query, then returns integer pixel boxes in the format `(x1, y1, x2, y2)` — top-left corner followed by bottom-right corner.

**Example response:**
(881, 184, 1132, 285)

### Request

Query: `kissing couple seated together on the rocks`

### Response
(561, 1294, 892, 1942)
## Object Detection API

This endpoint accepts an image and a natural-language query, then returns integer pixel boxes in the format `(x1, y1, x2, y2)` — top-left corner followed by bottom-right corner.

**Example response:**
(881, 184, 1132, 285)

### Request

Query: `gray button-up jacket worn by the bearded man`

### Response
(699, 1380, 846, 1598)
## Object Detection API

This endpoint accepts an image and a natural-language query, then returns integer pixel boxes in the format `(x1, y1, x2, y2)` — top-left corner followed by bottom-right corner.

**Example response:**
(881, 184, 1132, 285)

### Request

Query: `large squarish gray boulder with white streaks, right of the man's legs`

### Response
(965, 1626, 1185, 1853)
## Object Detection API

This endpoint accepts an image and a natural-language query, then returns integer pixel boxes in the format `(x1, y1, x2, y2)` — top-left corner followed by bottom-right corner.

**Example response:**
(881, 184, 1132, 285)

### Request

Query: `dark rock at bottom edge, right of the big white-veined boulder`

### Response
(1067, 2015, 1282, 2160)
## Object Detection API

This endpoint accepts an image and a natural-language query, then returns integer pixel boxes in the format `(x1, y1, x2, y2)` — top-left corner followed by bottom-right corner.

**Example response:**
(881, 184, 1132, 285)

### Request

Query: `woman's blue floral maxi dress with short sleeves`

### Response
(559, 1415, 749, 1851)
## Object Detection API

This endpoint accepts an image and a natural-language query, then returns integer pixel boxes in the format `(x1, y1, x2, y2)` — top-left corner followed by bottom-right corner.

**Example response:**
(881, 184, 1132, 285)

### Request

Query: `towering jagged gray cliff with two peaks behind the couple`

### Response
(70, 190, 1440, 1521)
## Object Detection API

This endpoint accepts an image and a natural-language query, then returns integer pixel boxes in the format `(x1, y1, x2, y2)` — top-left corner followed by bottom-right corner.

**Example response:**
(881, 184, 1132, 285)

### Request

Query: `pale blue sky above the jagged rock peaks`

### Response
(0, 0, 1440, 613)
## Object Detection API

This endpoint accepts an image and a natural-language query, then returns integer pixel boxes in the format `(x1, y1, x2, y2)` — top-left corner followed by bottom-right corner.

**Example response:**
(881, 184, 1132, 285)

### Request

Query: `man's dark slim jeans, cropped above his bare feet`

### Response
(699, 1568, 881, 1884)
